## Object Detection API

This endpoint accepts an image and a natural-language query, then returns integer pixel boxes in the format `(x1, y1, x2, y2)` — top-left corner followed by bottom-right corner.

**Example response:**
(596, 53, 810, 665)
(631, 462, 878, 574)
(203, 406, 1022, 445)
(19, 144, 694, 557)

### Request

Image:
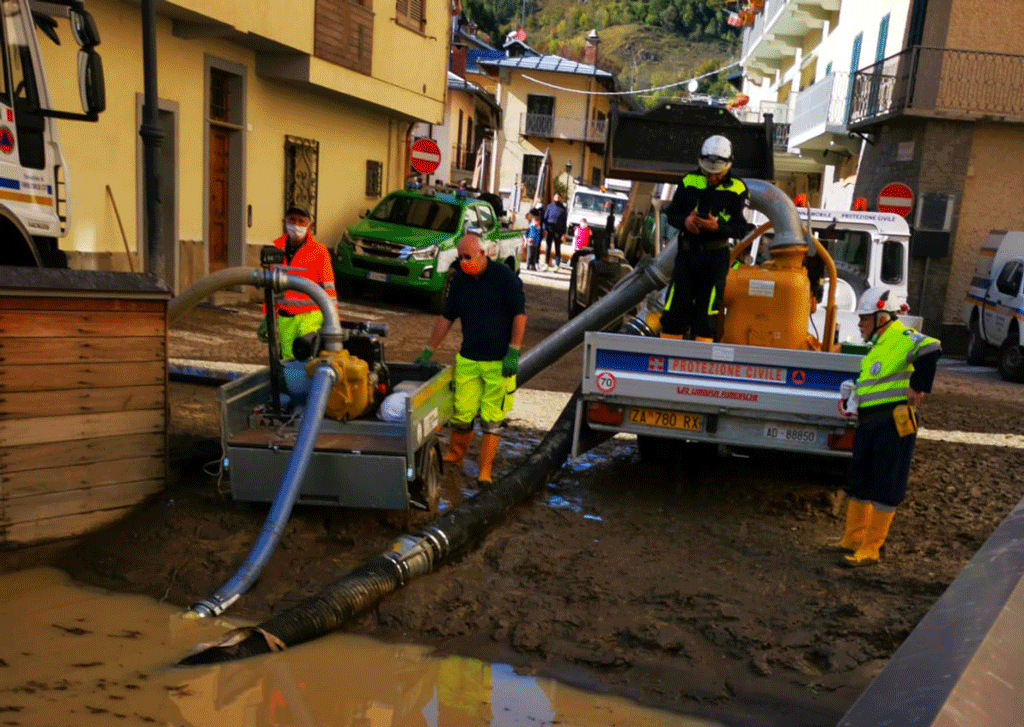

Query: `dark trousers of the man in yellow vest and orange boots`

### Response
(844, 404, 918, 507)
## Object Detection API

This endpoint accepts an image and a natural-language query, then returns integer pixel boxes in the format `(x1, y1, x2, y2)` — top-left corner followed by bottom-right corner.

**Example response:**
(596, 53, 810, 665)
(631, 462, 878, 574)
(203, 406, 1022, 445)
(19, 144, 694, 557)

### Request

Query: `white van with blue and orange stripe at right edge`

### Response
(964, 229, 1024, 382)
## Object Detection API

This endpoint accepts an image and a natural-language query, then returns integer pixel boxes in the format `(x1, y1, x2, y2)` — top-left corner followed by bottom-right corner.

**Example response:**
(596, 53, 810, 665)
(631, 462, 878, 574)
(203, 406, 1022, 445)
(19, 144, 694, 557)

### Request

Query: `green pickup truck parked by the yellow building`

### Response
(333, 191, 522, 312)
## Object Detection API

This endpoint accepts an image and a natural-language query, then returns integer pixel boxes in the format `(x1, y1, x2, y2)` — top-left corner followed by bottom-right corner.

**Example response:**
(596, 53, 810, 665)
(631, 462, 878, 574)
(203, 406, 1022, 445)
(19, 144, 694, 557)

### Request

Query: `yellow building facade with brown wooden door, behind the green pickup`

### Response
(39, 0, 450, 290)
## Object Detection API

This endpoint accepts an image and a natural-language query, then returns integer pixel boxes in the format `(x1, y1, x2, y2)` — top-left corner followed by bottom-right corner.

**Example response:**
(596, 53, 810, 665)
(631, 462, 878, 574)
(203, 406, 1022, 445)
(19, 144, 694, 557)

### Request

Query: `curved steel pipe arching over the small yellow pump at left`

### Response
(167, 267, 342, 351)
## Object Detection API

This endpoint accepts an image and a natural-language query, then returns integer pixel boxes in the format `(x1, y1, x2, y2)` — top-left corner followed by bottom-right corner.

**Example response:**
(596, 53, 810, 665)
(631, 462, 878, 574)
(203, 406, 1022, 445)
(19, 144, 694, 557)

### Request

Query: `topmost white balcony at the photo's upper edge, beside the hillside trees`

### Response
(739, 0, 841, 75)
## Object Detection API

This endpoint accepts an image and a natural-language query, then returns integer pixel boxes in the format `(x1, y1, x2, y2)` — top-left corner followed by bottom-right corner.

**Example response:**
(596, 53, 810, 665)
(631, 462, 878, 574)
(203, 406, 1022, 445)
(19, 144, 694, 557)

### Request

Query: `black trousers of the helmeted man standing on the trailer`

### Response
(662, 243, 729, 338)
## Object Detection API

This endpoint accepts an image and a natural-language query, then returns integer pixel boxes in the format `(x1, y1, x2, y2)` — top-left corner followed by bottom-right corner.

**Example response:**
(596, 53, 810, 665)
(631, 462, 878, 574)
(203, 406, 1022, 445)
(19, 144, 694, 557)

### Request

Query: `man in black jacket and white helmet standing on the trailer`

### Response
(662, 135, 751, 341)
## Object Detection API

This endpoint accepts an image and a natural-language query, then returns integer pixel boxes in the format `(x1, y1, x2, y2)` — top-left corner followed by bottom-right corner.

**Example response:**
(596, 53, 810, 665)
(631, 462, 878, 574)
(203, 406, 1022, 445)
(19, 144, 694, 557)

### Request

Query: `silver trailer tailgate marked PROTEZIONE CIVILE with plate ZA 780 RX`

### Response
(572, 333, 860, 459)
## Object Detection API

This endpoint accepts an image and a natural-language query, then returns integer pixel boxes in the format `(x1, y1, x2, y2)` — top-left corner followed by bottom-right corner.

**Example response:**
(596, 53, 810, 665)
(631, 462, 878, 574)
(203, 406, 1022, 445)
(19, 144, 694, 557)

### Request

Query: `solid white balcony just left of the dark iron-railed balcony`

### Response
(790, 73, 860, 154)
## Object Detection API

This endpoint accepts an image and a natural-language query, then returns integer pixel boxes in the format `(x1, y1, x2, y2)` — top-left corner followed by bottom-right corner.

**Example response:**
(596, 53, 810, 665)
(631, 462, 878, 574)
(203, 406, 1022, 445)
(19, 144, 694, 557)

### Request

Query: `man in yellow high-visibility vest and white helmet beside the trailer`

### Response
(829, 286, 942, 566)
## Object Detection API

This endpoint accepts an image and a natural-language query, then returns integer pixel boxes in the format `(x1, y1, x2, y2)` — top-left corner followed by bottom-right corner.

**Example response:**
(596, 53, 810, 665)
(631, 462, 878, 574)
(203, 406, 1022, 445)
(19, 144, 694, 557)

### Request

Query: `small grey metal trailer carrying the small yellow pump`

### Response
(217, 364, 454, 511)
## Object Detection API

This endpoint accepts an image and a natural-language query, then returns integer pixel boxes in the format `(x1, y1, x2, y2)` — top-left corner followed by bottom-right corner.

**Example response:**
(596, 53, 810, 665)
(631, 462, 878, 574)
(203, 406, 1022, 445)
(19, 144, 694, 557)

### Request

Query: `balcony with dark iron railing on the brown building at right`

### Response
(848, 45, 1024, 130)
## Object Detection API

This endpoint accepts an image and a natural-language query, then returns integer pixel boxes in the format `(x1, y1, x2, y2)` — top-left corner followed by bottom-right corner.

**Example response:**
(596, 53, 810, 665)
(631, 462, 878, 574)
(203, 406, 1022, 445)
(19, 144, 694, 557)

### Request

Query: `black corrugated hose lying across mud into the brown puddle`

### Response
(179, 389, 580, 666)
